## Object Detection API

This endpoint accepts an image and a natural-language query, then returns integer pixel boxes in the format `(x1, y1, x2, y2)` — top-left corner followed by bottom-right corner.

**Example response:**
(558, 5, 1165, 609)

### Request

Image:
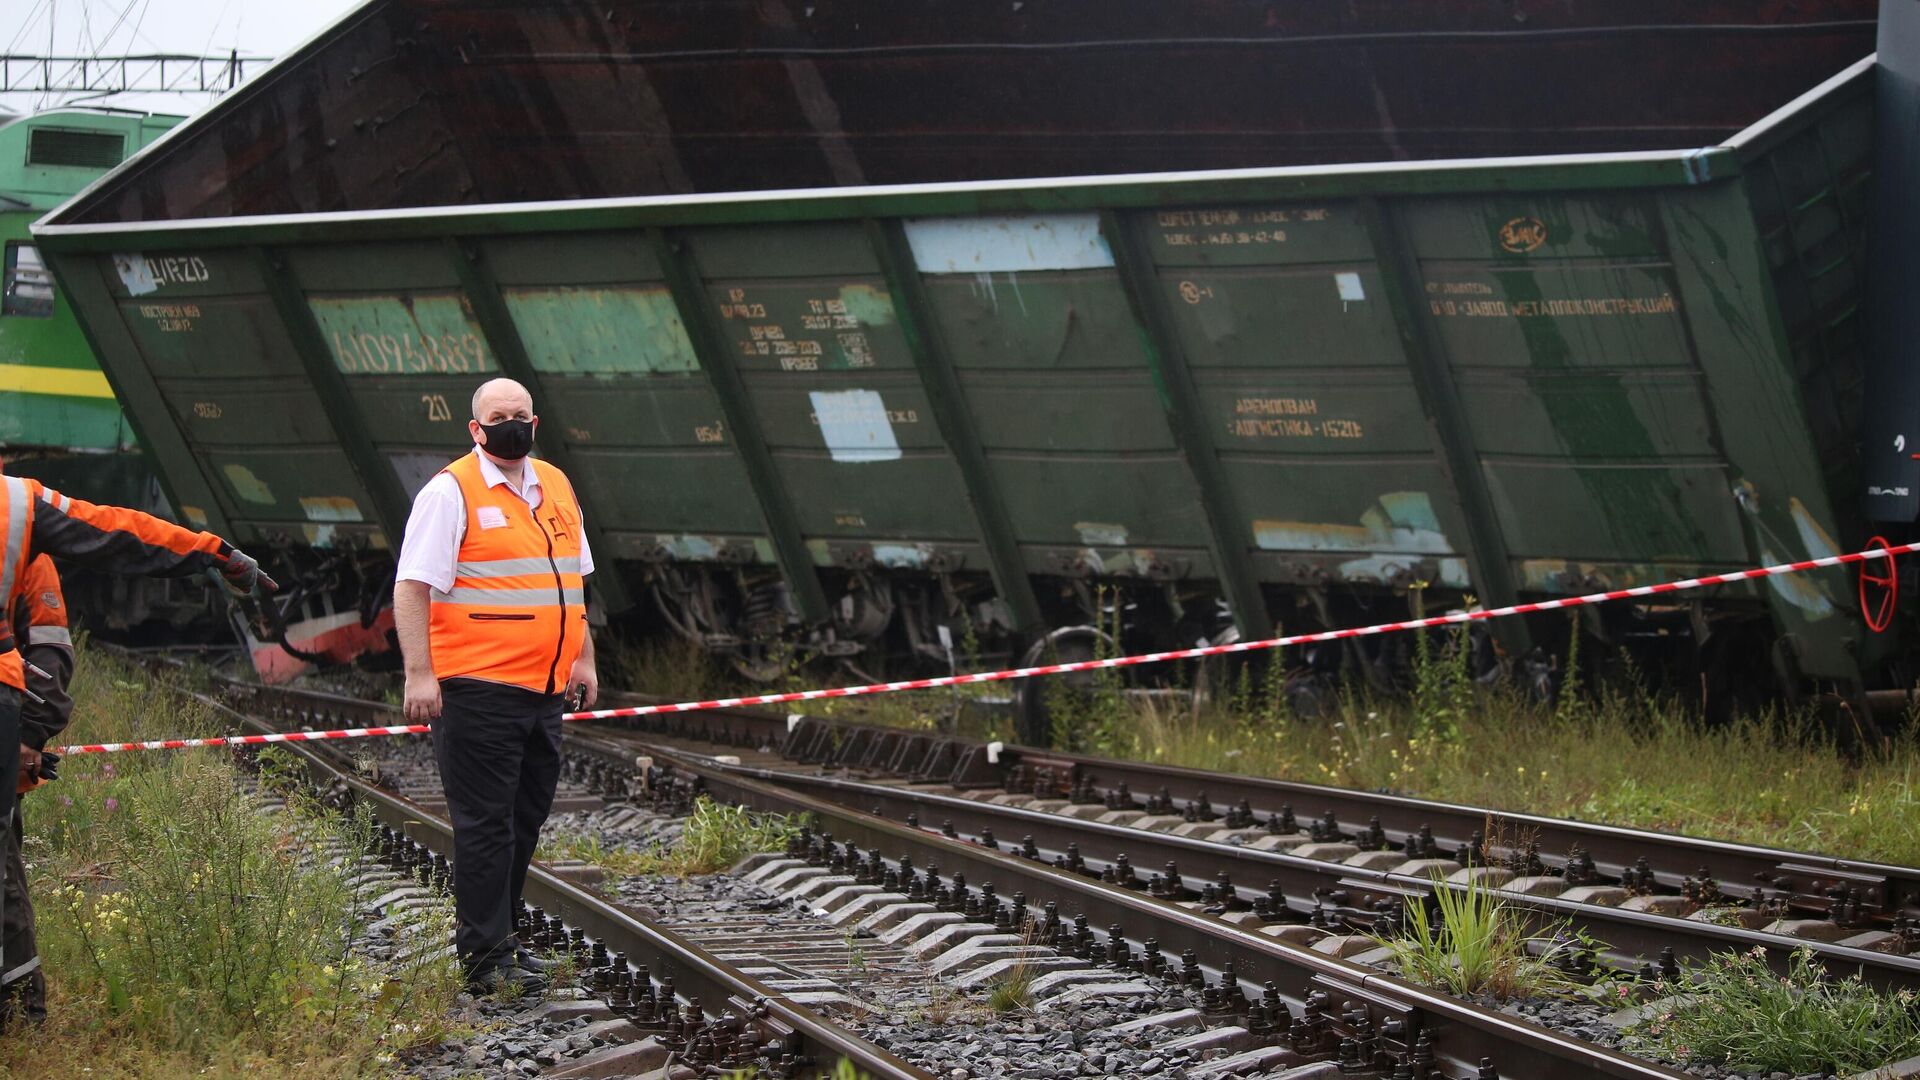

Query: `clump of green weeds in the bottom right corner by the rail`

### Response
(1628, 949, 1920, 1076)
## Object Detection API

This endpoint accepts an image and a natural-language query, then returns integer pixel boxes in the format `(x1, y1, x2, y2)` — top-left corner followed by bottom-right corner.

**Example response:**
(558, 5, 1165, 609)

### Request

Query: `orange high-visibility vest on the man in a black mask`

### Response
(426, 454, 588, 694)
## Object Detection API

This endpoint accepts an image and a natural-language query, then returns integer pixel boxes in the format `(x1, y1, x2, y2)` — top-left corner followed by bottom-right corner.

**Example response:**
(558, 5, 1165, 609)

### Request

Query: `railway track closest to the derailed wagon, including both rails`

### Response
(314, 676, 1920, 990)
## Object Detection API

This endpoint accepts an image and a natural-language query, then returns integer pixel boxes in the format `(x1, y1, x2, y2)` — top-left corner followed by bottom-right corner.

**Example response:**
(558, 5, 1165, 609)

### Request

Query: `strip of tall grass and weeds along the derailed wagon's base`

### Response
(603, 634, 1920, 867)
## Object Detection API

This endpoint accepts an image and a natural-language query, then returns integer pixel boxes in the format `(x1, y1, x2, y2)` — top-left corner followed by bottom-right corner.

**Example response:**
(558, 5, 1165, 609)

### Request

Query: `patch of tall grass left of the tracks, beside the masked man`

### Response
(0, 648, 459, 1080)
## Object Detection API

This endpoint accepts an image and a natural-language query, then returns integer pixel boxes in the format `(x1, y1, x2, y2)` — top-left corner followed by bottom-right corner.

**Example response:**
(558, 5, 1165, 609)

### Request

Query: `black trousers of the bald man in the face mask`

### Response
(434, 678, 563, 972)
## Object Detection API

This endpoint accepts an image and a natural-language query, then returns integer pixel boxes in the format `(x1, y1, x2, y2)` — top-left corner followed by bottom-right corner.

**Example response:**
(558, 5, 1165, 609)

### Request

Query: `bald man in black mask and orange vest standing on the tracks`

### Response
(394, 379, 599, 990)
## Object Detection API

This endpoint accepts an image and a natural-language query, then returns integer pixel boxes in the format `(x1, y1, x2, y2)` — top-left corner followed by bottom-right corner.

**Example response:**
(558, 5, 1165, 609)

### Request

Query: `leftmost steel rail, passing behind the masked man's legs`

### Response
(181, 680, 933, 1080)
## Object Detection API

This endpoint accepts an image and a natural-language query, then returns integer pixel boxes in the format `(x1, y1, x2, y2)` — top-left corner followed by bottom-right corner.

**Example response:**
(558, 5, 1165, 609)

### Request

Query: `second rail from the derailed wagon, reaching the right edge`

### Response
(572, 732, 1920, 992)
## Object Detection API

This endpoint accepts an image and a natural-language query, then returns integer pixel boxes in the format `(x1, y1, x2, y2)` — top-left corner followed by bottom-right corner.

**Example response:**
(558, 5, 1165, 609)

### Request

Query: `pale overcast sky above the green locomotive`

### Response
(0, 0, 361, 113)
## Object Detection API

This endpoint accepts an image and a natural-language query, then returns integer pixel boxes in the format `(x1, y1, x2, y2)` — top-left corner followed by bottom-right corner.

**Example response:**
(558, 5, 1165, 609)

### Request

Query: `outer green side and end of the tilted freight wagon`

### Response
(36, 6, 1887, 707)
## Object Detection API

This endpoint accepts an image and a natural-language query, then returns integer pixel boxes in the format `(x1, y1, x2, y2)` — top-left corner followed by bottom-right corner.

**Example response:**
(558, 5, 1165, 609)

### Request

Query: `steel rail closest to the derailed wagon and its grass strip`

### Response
(603, 692, 1920, 917)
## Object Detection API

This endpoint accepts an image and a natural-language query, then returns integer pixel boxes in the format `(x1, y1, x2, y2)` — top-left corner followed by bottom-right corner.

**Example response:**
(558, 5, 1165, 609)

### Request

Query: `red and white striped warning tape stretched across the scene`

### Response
(58, 542, 1920, 755)
